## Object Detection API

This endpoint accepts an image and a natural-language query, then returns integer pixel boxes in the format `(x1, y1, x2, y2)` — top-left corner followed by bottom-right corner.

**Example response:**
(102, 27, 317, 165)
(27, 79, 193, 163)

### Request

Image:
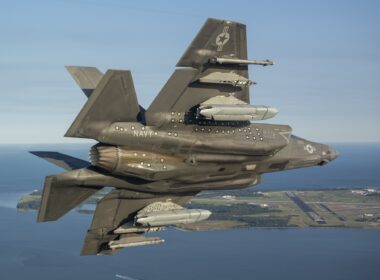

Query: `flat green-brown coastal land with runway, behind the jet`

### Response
(17, 189, 380, 230)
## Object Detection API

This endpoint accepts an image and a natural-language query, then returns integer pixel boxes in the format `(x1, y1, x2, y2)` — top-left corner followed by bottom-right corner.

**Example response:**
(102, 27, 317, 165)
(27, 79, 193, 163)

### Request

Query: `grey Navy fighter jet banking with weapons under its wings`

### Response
(32, 19, 337, 255)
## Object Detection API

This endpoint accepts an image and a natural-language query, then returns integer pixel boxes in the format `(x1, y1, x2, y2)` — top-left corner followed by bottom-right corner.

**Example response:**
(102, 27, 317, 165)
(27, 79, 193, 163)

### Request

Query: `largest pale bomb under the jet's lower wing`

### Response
(136, 208, 211, 226)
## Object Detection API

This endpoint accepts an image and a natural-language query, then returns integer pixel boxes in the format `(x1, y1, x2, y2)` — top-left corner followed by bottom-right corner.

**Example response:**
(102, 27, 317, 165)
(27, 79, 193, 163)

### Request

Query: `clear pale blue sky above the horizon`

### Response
(0, 0, 380, 144)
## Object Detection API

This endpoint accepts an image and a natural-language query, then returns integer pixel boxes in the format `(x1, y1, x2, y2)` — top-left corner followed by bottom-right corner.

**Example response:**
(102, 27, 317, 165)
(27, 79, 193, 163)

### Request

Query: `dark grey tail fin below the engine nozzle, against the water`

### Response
(37, 173, 103, 222)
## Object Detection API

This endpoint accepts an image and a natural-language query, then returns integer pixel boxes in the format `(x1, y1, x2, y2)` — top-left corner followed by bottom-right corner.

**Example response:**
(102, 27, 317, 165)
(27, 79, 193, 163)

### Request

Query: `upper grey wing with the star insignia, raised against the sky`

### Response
(146, 18, 252, 125)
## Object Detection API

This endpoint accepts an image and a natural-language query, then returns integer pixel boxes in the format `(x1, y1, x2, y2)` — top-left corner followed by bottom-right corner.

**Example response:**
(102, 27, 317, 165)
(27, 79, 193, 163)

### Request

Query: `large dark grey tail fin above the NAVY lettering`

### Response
(65, 70, 140, 139)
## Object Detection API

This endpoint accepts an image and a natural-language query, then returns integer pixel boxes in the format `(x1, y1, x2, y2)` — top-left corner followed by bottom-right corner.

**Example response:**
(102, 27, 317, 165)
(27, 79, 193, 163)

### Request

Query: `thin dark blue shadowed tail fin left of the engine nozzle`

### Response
(30, 151, 91, 170)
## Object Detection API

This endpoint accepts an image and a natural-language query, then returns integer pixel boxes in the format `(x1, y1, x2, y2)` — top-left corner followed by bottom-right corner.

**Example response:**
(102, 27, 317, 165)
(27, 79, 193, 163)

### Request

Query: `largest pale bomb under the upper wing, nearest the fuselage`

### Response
(198, 104, 278, 121)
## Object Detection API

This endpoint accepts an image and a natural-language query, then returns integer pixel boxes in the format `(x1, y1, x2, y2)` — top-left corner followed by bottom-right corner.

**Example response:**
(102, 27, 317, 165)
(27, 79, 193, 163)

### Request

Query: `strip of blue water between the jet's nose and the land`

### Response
(259, 144, 380, 190)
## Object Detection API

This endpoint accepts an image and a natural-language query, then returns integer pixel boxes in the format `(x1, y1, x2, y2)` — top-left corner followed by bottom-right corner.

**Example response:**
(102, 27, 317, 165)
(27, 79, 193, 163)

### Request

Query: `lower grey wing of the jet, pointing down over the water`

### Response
(81, 189, 196, 255)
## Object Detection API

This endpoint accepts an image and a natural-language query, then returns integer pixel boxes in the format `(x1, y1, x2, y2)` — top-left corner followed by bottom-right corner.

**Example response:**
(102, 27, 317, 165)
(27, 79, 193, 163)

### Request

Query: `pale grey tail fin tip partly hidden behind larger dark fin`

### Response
(66, 66, 103, 97)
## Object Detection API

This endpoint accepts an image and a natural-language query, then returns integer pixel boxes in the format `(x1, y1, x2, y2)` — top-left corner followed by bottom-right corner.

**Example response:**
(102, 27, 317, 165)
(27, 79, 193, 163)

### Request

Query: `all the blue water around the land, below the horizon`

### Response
(0, 144, 380, 280)
